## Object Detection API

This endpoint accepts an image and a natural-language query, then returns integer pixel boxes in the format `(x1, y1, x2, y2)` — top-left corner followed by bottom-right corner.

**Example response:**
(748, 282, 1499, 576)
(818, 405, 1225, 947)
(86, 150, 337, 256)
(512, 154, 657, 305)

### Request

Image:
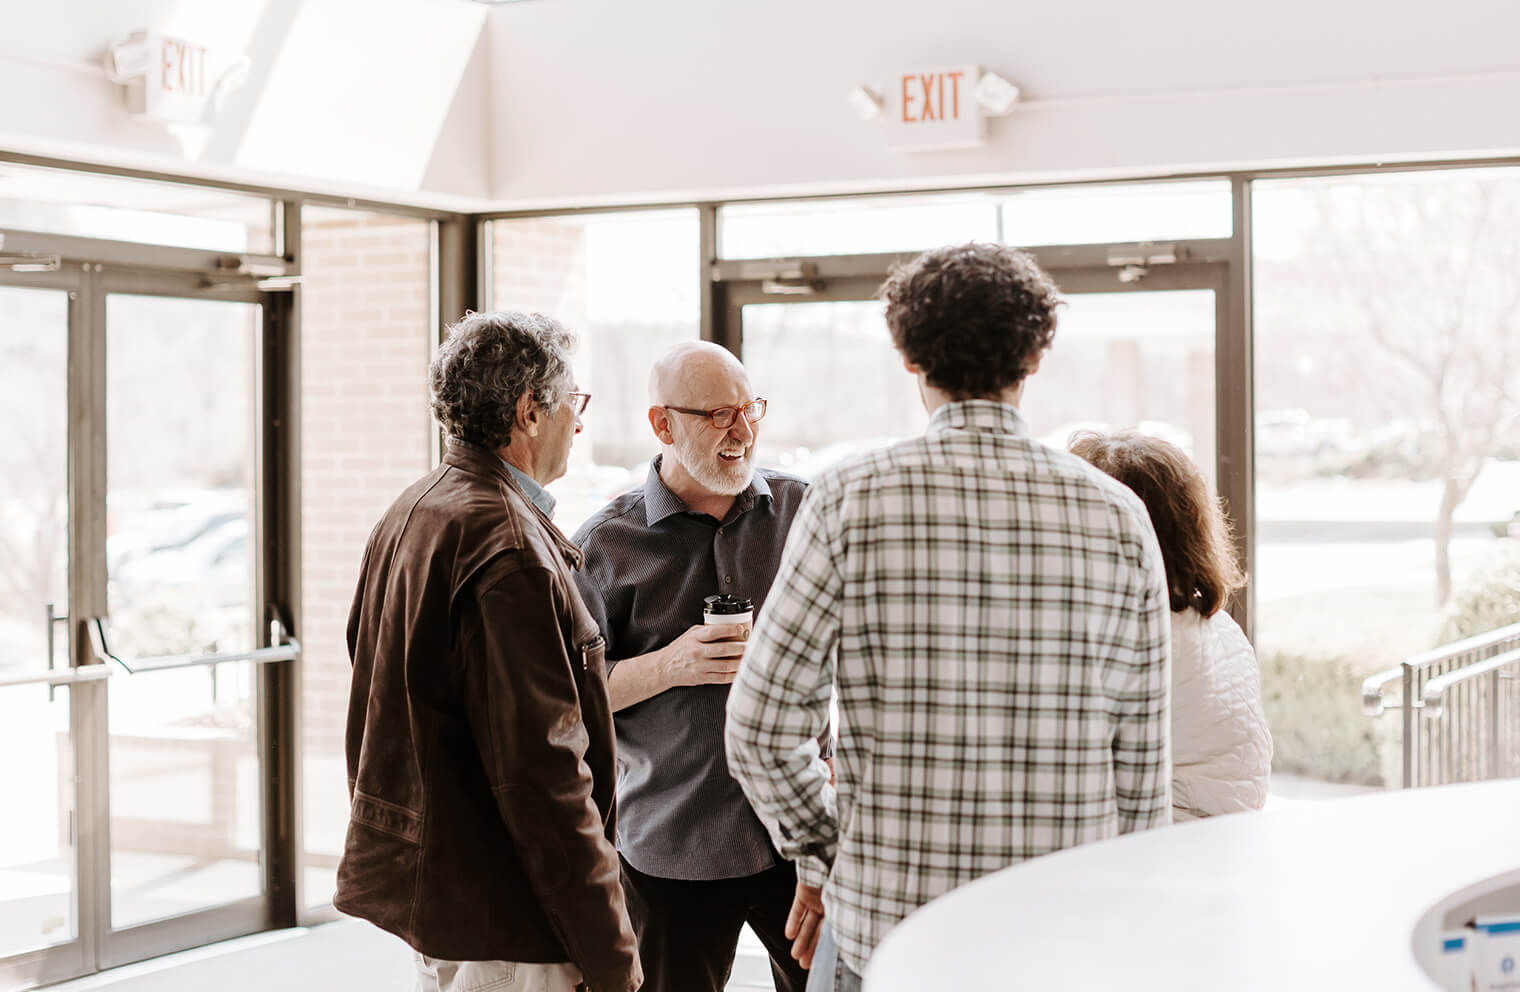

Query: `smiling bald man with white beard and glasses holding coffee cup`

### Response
(575, 342, 807, 992)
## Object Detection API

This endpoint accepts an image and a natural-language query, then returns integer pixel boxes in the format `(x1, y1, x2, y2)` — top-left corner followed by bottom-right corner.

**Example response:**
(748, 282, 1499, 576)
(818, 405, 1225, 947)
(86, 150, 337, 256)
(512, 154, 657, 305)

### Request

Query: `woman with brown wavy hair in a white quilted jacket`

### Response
(1072, 430, 1272, 820)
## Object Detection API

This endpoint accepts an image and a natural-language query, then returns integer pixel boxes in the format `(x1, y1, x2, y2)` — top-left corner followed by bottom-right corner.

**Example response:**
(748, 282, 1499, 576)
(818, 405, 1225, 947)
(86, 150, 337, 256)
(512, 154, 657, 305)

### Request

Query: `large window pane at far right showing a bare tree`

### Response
(1254, 170, 1520, 785)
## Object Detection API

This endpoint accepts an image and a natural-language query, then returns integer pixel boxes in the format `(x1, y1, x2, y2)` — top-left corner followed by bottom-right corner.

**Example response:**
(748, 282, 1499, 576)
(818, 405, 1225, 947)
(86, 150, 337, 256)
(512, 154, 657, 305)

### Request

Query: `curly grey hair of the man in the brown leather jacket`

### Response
(427, 310, 575, 450)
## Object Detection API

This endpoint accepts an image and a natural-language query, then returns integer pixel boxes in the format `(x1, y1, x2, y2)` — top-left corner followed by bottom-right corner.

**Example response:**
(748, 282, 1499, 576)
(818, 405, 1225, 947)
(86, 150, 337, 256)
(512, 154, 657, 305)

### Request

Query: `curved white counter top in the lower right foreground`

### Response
(865, 779, 1520, 992)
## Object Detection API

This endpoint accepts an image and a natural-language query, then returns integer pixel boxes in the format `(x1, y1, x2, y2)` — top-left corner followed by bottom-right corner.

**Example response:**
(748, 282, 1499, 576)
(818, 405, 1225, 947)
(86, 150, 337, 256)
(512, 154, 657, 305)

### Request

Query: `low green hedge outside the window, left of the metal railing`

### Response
(1260, 653, 1397, 785)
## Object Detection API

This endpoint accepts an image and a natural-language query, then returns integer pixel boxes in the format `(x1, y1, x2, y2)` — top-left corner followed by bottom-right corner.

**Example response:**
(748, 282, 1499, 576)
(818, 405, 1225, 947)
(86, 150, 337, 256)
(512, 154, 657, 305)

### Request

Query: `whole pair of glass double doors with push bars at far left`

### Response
(0, 266, 298, 987)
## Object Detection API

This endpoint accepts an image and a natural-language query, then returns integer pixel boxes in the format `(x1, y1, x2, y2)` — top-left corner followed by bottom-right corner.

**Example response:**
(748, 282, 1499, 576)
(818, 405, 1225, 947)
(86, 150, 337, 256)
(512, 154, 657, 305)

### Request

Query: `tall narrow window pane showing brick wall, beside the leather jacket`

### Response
(301, 207, 432, 907)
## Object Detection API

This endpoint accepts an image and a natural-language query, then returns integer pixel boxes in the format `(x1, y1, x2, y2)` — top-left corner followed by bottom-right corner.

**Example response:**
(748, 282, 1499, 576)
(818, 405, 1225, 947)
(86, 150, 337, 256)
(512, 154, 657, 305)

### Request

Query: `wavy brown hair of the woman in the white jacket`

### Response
(1070, 430, 1245, 617)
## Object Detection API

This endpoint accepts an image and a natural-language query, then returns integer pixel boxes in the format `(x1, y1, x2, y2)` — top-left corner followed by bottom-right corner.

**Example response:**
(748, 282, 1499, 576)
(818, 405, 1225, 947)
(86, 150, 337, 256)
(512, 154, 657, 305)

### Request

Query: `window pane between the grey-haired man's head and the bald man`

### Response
(491, 210, 701, 533)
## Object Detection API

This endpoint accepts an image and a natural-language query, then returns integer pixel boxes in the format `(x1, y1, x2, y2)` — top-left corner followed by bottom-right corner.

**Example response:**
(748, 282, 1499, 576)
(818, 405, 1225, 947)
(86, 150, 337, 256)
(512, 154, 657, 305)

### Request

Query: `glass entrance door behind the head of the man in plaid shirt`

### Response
(730, 266, 1243, 549)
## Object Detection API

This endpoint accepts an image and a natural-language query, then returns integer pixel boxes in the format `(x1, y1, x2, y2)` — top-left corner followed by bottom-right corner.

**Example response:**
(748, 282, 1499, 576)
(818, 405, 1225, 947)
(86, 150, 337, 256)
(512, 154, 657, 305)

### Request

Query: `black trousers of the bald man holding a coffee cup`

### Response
(623, 861, 807, 992)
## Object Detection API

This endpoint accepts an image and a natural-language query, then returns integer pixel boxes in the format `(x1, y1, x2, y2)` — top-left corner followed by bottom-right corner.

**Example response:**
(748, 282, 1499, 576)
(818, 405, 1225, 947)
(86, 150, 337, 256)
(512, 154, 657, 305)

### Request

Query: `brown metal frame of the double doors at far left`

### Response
(0, 246, 299, 987)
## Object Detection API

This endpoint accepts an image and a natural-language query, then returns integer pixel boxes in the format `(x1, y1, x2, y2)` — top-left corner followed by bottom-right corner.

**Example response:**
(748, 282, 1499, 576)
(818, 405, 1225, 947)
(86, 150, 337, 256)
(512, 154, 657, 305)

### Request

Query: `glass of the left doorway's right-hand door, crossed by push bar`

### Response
(106, 295, 263, 928)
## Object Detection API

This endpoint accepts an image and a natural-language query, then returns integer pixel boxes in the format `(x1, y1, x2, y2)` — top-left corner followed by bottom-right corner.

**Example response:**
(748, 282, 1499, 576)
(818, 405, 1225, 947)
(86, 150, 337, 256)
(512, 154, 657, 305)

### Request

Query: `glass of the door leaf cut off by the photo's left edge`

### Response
(0, 272, 99, 984)
